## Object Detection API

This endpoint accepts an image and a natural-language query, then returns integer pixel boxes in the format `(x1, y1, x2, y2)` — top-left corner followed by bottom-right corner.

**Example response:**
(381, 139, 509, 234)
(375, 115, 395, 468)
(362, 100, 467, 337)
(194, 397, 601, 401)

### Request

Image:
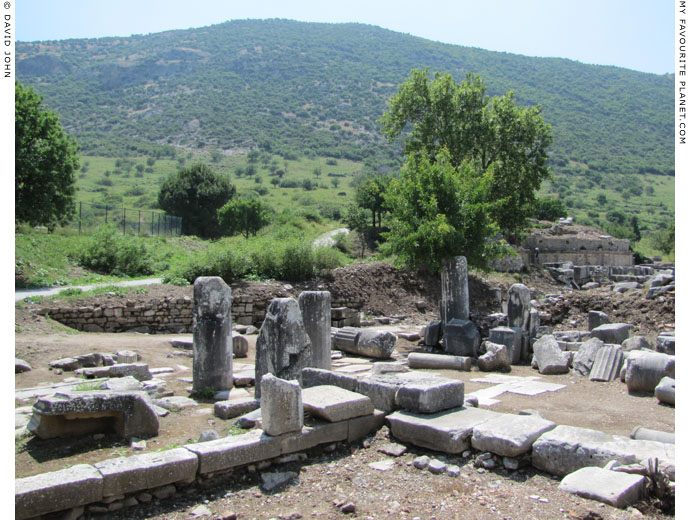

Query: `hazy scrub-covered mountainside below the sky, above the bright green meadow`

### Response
(16, 20, 674, 176)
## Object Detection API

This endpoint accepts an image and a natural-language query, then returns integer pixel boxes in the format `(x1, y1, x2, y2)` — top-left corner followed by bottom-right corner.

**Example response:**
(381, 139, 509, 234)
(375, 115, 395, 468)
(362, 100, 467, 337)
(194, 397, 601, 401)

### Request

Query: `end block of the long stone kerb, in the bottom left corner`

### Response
(14, 464, 103, 520)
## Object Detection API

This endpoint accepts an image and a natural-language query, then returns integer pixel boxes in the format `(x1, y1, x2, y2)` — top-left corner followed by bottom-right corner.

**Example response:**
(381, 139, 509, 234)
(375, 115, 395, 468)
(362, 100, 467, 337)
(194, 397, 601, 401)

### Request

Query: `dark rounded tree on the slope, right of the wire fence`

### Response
(158, 164, 235, 238)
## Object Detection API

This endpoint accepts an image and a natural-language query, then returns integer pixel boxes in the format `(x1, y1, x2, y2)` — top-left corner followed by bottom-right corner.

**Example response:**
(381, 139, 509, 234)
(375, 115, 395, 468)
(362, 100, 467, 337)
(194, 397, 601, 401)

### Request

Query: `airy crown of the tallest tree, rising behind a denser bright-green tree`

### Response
(380, 69, 552, 244)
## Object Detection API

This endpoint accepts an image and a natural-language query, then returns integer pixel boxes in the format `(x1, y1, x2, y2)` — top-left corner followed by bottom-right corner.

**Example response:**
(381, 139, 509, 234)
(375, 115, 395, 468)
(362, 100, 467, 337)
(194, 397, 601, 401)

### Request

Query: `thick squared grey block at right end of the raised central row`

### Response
(395, 377, 465, 413)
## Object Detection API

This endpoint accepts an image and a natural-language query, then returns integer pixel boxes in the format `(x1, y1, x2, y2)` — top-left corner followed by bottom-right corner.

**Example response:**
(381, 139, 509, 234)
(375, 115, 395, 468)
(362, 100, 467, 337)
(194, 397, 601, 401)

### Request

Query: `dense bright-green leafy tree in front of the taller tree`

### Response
(384, 148, 500, 272)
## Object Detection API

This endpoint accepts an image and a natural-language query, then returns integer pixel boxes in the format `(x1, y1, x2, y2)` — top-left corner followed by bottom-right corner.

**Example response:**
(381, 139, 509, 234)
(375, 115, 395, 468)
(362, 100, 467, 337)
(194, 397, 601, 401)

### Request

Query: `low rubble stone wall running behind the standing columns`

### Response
(37, 294, 363, 334)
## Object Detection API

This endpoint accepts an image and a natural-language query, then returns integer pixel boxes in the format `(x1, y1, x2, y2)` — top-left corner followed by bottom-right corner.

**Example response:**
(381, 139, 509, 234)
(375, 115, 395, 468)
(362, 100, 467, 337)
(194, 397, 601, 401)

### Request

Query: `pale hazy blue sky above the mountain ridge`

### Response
(16, 0, 674, 74)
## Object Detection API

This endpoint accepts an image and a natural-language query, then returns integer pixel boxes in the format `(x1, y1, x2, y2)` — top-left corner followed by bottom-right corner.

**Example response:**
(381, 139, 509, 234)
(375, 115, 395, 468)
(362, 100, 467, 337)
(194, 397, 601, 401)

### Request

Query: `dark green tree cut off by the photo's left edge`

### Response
(14, 81, 79, 229)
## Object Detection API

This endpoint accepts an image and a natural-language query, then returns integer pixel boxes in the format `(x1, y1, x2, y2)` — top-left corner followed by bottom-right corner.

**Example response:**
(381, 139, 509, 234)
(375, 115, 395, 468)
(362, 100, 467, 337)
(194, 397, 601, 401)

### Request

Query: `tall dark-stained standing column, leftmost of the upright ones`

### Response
(193, 276, 232, 392)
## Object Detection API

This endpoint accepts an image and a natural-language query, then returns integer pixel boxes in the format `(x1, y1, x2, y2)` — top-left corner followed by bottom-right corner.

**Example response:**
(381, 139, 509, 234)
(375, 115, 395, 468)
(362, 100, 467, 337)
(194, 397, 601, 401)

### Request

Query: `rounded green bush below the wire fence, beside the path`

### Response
(79, 225, 153, 276)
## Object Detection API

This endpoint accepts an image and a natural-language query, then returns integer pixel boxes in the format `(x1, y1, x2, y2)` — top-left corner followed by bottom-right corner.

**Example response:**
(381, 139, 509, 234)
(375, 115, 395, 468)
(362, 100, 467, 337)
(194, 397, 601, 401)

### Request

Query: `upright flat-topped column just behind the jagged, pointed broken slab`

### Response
(297, 291, 331, 370)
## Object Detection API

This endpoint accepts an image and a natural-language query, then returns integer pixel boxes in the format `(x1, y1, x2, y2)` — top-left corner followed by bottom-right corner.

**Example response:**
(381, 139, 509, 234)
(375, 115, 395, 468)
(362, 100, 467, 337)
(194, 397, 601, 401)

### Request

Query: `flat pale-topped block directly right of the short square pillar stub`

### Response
(302, 385, 374, 422)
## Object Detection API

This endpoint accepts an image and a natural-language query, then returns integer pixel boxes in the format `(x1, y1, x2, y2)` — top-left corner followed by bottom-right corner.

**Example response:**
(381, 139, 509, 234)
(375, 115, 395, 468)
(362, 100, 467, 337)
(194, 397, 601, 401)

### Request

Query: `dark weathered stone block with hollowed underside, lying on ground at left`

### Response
(27, 391, 158, 439)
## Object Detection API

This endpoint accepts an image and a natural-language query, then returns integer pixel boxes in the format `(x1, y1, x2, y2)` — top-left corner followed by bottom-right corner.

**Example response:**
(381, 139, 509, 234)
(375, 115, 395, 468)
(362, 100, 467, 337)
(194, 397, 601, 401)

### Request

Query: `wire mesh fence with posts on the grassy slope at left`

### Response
(72, 202, 182, 237)
